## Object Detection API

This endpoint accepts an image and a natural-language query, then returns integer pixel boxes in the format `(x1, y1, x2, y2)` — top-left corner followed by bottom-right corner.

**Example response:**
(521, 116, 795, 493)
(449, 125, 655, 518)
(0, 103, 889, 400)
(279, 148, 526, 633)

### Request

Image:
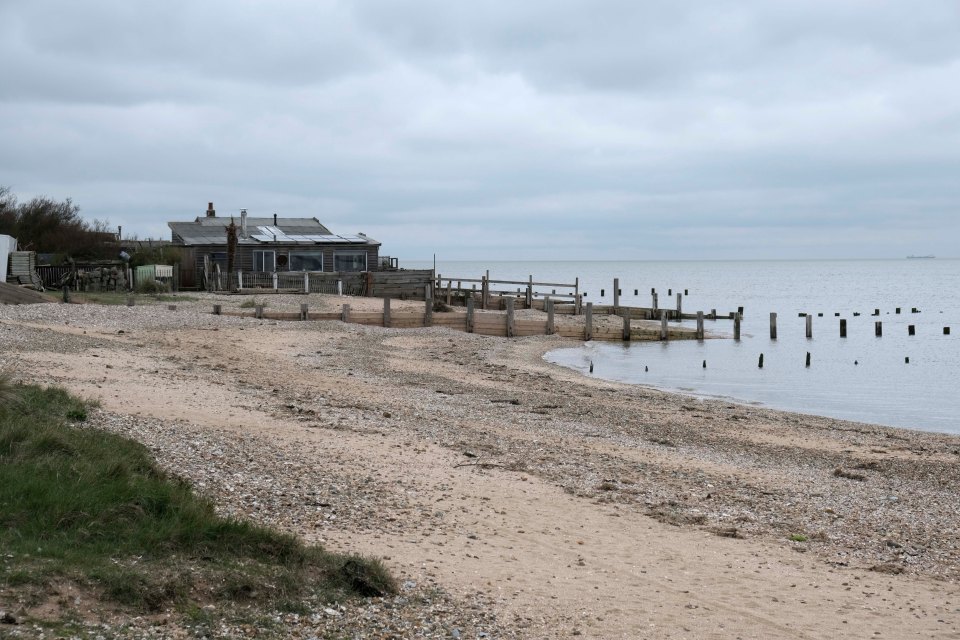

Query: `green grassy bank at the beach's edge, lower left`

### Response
(0, 377, 396, 618)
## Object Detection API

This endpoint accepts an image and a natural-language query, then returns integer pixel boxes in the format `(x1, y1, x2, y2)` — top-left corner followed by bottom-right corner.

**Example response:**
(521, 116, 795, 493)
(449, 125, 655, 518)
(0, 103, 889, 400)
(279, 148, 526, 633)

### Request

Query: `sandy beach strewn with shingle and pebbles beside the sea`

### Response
(0, 294, 960, 638)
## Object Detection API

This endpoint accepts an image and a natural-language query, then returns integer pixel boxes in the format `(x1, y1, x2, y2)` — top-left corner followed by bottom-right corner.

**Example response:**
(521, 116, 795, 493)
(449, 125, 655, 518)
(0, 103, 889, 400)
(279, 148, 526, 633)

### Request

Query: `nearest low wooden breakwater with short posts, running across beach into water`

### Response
(213, 298, 704, 341)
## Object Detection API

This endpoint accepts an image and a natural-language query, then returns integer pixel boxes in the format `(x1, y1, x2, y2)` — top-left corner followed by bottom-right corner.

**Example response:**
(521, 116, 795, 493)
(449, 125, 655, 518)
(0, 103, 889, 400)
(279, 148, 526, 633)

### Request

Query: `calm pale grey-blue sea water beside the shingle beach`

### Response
(403, 259, 960, 433)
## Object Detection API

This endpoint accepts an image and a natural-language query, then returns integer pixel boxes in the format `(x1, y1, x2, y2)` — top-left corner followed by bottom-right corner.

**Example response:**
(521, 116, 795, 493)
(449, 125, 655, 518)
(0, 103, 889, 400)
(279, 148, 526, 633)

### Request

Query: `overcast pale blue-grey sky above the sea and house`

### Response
(0, 0, 960, 260)
